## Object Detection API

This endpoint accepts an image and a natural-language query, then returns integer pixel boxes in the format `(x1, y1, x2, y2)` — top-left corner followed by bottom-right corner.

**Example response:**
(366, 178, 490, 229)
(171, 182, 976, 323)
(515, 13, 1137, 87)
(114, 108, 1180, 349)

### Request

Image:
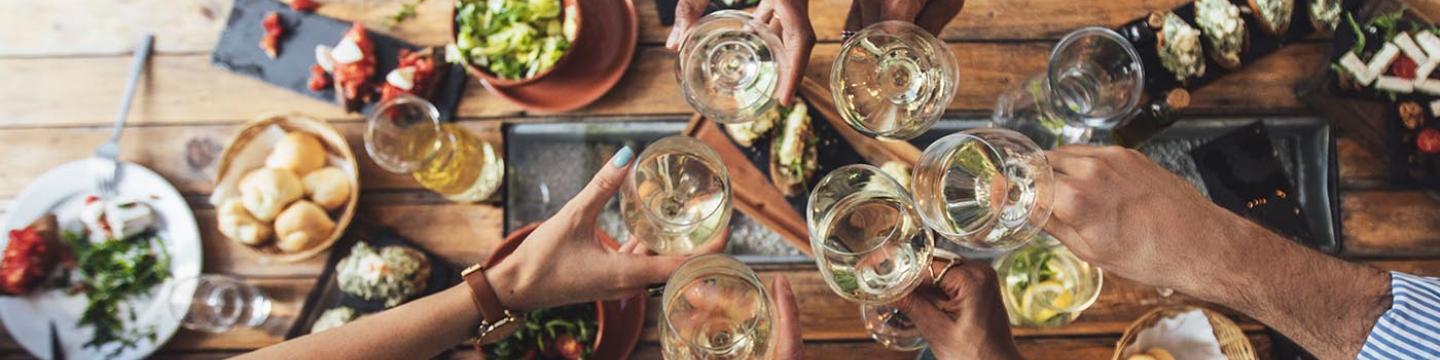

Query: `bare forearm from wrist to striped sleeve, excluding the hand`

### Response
(1182, 216, 1390, 359)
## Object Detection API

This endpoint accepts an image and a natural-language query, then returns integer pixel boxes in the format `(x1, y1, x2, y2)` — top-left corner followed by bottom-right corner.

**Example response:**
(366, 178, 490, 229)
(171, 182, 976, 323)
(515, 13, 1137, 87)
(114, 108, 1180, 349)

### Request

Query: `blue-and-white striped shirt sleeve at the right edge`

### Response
(1356, 272, 1440, 359)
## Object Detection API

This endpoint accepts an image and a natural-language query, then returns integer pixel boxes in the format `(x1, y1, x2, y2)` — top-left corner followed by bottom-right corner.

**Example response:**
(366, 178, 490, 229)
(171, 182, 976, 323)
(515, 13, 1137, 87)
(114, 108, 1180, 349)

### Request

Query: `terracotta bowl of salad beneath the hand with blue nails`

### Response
(485, 223, 645, 359)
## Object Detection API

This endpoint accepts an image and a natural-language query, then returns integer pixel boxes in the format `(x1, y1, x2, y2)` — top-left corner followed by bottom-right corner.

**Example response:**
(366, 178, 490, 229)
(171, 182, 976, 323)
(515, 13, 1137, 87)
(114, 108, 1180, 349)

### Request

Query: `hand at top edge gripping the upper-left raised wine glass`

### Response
(665, 0, 815, 107)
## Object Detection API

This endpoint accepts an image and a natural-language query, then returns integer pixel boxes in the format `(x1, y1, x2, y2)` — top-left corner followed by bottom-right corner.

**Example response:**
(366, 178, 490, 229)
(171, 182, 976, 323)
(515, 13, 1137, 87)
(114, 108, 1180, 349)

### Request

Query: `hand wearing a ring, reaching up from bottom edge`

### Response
(896, 259, 1021, 359)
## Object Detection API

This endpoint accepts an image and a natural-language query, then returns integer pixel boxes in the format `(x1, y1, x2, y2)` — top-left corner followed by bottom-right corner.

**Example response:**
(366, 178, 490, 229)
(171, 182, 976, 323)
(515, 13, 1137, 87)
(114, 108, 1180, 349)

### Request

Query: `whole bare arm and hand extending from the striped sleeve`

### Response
(1045, 145, 1391, 359)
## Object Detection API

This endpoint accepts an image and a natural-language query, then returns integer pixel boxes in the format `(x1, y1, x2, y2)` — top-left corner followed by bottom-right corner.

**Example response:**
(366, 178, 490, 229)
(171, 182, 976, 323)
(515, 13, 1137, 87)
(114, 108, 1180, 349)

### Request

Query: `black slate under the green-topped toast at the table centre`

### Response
(720, 97, 865, 215)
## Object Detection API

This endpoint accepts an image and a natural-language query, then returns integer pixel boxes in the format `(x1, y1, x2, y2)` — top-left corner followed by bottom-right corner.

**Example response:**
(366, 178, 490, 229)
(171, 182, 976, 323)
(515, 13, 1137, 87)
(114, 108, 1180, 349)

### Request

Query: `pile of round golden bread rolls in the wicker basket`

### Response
(216, 131, 356, 253)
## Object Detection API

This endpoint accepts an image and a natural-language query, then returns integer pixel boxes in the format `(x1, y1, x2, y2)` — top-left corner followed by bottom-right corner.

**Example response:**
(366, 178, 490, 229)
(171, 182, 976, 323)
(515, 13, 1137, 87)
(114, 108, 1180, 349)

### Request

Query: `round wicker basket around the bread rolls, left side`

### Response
(210, 114, 360, 262)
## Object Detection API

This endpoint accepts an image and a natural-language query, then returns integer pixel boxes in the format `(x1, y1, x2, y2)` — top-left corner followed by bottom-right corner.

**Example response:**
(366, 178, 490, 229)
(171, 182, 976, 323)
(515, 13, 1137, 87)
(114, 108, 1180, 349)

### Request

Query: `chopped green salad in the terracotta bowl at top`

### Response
(449, 0, 576, 79)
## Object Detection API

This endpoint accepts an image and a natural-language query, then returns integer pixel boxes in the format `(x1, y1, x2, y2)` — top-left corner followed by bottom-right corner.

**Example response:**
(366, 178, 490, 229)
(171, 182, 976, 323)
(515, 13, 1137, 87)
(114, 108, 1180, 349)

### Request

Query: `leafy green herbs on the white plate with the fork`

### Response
(62, 232, 170, 356)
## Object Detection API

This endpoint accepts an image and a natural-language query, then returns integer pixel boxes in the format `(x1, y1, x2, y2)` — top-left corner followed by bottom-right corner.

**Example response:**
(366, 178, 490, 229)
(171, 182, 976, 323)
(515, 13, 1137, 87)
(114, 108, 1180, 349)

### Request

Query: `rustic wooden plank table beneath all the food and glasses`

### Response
(0, 0, 1440, 359)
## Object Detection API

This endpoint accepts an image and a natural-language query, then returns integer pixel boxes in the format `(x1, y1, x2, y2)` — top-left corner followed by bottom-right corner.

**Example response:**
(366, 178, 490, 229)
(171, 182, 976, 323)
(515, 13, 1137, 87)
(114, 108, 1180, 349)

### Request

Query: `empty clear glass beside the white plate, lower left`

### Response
(167, 275, 272, 334)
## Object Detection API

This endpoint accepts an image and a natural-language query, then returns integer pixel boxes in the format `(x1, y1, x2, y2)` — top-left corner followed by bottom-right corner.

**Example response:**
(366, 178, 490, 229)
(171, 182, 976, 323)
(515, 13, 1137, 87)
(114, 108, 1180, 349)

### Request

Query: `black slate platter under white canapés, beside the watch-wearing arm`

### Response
(285, 222, 461, 340)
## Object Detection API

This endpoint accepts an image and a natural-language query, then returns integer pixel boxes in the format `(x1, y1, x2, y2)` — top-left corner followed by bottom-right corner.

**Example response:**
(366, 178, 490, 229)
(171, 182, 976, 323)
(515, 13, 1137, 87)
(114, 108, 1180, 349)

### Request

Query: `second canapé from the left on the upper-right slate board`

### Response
(1195, 0, 1248, 69)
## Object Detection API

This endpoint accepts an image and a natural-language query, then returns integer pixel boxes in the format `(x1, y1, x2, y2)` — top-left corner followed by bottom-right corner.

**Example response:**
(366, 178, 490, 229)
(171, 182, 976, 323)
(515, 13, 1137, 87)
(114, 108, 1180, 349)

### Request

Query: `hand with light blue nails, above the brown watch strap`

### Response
(485, 147, 685, 311)
